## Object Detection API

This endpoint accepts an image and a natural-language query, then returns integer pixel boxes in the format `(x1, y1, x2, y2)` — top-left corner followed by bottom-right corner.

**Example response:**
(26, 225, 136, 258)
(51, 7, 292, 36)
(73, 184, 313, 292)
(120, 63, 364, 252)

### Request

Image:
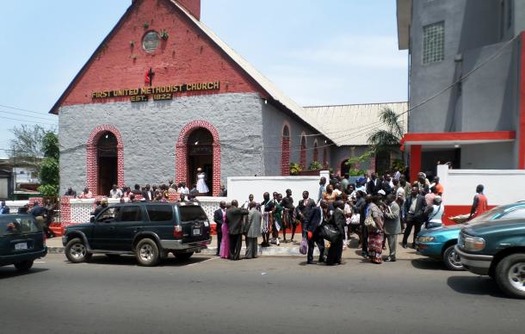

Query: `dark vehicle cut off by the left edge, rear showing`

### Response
(0, 214, 47, 271)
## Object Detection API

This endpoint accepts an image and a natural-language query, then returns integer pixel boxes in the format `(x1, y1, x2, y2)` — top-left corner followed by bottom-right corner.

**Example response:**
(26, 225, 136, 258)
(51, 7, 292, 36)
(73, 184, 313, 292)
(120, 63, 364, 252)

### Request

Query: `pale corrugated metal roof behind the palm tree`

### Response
(303, 102, 408, 146)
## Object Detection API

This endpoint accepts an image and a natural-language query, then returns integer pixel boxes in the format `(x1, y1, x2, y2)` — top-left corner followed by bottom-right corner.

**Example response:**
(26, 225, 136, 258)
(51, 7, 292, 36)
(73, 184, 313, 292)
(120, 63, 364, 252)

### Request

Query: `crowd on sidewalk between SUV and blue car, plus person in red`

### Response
(214, 172, 487, 265)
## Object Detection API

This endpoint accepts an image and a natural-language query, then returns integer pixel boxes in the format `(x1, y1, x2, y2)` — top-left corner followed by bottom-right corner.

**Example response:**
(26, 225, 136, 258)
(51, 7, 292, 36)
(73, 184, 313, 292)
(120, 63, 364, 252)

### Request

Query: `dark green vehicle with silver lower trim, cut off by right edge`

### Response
(456, 204, 525, 298)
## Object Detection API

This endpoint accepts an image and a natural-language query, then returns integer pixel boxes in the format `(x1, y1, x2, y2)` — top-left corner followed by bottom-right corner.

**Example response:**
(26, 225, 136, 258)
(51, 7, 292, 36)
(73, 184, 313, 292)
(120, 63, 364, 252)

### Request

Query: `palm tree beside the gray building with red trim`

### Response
(368, 107, 404, 172)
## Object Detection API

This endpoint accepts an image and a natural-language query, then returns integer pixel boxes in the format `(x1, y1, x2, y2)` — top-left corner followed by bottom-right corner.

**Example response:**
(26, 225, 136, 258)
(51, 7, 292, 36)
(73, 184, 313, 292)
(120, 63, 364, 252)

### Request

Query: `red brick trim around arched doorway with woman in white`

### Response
(175, 120, 221, 196)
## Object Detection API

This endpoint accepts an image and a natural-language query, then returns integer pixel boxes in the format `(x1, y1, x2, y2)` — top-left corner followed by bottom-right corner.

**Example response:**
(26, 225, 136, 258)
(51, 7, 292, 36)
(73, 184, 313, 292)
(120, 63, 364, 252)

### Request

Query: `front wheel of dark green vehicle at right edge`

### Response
(495, 254, 525, 299)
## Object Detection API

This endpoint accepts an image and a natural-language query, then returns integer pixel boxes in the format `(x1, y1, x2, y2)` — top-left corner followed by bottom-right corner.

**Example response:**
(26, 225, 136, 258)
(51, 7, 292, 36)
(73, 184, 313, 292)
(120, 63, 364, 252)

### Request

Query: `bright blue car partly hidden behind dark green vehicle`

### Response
(416, 201, 525, 271)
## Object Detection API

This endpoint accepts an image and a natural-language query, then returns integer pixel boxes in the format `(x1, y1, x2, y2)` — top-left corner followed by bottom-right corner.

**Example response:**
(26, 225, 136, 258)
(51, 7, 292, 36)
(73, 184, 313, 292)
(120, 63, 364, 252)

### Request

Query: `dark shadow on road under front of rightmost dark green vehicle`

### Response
(447, 274, 508, 298)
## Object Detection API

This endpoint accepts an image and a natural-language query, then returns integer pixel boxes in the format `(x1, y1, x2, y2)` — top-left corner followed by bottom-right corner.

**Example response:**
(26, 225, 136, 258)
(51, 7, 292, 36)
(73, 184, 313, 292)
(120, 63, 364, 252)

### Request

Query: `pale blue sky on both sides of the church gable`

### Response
(0, 0, 408, 158)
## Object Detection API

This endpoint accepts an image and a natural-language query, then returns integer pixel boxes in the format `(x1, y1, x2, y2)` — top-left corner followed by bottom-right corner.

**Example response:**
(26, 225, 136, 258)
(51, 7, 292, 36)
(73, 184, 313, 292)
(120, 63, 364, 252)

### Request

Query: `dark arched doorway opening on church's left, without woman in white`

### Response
(96, 131, 118, 194)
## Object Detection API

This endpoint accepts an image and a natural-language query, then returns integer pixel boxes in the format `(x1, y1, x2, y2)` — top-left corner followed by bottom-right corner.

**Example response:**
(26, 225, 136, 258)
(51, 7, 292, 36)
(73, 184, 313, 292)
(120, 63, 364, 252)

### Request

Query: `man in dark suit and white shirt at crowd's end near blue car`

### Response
(401, 186, 426, 248)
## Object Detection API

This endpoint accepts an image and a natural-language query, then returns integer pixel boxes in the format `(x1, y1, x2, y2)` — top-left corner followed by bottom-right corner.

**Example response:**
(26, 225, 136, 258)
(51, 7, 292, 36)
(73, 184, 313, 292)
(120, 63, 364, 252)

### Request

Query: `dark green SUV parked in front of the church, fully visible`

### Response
(62, 202, 211, 266)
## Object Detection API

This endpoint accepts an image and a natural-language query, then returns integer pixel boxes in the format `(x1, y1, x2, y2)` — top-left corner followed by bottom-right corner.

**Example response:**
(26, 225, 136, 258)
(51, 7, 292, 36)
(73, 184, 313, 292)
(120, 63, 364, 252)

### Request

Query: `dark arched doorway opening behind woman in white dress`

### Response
(186, 128, 213, 192)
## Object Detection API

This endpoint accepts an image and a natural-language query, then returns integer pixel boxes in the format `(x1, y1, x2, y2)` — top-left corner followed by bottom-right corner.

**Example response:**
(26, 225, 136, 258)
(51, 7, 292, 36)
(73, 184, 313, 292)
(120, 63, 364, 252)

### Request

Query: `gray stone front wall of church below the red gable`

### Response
(59, 94, 264, 193)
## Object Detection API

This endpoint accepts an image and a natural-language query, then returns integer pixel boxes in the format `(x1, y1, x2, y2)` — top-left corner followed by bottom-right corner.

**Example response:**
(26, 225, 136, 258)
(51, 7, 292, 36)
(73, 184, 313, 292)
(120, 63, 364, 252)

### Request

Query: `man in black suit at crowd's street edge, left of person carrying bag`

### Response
(304, 199, 328, 264)
